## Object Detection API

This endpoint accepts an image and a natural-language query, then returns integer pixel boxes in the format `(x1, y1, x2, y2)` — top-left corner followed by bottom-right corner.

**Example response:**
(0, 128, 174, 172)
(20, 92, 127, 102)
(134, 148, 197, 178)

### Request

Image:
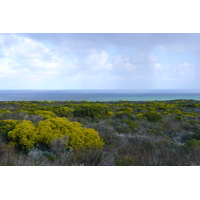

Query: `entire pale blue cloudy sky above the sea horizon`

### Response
(0, 33, 200, 90)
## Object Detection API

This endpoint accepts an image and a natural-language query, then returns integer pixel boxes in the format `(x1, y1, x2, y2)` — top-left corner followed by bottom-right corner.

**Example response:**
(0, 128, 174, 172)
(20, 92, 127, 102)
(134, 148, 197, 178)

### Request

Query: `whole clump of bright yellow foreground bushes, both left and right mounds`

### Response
(5, 117, 104, 149)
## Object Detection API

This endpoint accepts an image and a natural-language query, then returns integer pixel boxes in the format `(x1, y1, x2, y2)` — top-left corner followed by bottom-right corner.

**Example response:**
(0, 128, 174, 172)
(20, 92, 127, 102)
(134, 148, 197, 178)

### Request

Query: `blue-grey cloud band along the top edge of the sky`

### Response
(25, 33, 200, 48)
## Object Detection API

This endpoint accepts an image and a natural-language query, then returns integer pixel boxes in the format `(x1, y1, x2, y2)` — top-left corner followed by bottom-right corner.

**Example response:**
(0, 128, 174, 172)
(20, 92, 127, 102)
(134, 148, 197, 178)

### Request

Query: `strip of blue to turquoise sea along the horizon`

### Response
(0, 90, 200, 101)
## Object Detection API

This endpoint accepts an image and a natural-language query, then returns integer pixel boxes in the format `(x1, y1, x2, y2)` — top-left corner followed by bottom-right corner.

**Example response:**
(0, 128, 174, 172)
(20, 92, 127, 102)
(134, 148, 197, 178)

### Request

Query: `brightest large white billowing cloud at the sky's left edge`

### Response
(0, 34, 67, 81)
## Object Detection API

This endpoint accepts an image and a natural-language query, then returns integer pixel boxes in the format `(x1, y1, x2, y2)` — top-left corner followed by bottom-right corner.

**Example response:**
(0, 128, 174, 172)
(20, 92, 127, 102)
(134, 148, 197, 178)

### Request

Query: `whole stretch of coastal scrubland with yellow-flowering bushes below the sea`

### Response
(0, 100, 200, 166)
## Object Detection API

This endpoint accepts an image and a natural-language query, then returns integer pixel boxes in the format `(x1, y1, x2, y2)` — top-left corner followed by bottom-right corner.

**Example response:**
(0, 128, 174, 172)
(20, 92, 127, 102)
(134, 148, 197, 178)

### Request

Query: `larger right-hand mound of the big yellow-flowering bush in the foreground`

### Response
(37, 117, 104, 149)
